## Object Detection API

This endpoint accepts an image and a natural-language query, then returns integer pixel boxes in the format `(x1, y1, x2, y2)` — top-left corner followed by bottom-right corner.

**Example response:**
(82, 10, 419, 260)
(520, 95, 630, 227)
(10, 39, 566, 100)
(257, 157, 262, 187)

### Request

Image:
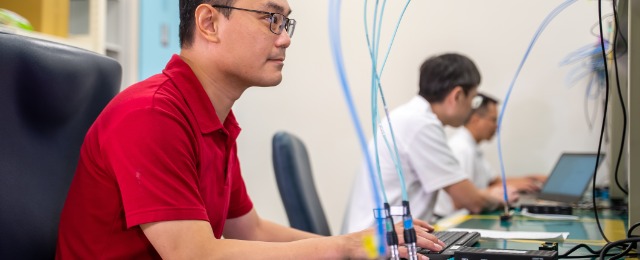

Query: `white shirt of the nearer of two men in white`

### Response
(342, 96, 467, 233)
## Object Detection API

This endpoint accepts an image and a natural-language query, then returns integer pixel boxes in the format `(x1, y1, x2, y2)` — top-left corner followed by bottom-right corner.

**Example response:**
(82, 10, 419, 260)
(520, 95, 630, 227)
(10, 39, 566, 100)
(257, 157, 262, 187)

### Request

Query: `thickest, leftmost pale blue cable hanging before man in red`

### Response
(329, 0, 386, 256)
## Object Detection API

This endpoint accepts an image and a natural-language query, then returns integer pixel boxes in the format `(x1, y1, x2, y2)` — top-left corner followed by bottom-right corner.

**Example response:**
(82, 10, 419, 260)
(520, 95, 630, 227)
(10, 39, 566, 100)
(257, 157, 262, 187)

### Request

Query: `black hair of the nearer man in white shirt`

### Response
(418, 53, 481, 103)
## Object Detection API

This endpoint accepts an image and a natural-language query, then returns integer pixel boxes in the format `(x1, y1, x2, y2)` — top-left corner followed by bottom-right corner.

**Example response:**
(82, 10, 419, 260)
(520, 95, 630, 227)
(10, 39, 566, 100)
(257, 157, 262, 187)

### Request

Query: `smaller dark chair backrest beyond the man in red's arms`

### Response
(272, 132, 331, 236)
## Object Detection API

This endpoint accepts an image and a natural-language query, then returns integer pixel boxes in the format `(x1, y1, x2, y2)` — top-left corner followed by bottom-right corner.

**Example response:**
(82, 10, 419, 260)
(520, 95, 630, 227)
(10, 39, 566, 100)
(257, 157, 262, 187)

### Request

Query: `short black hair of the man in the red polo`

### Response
(178, 0, 236, 48)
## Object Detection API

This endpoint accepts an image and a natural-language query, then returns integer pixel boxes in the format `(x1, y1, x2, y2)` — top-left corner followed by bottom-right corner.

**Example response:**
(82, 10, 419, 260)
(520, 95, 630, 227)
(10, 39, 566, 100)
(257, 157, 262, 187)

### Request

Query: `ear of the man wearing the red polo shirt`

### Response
(194, 4, 224, 42)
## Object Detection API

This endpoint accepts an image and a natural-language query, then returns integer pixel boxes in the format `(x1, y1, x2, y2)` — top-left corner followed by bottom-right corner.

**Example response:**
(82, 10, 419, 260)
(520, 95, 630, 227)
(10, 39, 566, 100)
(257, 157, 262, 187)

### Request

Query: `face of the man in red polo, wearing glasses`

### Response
(214, 0, 291, 86)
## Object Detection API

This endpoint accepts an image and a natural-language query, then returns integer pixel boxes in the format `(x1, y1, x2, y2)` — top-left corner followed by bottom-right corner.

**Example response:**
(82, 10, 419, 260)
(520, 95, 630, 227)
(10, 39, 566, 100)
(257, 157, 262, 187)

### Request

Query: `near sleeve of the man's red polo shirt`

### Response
(102, 107, 208, 227)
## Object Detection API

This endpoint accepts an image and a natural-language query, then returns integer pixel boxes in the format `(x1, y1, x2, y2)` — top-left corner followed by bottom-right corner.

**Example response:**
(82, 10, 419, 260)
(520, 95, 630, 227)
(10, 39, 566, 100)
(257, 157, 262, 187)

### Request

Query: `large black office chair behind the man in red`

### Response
(0, 32, 122, 259)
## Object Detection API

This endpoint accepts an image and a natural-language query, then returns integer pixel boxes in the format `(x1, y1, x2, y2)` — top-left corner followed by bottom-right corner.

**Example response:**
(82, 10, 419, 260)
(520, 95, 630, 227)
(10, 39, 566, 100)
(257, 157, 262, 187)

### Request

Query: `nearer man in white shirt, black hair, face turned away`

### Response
(342, 54, 501, 232)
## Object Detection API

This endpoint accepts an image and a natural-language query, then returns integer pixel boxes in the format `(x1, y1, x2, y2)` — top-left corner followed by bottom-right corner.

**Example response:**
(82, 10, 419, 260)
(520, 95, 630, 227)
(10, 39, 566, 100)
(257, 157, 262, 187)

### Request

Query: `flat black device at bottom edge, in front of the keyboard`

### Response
(453, 247, 558, 260)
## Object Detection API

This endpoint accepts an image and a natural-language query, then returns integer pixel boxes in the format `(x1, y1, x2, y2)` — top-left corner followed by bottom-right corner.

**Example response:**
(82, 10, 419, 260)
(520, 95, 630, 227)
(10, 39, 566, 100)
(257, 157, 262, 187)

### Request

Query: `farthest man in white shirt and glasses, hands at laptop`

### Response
(435, 93, 546, 217)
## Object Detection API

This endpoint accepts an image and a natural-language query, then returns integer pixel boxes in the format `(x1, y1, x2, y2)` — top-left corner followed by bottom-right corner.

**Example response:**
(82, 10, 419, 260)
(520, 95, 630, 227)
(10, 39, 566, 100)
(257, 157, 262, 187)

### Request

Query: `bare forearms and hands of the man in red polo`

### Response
(140, 211, 444, 259)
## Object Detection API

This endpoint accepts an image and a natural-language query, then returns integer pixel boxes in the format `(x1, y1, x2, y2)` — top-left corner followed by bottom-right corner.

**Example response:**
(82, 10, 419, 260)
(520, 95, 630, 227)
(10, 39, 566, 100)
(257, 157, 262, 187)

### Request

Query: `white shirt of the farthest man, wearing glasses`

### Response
(435, 127, 498, 217)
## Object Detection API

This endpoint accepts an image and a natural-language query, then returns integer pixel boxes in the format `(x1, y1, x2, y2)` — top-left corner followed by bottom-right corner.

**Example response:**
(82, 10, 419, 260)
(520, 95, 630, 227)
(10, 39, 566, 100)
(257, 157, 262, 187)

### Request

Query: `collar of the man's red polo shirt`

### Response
(163, 54, 240, 139)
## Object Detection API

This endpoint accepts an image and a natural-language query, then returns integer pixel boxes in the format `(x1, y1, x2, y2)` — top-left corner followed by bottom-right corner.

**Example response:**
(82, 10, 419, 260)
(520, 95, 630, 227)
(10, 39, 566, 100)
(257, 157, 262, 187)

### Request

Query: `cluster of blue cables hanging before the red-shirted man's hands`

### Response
(329, 0, 417, 260)
